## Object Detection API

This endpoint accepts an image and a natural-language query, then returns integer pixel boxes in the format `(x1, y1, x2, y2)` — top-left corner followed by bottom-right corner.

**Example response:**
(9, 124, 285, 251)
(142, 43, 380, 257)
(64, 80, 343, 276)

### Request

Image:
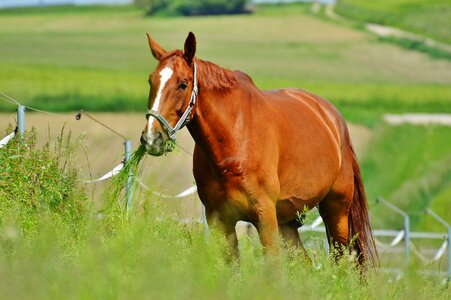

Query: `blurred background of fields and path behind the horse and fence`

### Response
(0, 0, 451, 270)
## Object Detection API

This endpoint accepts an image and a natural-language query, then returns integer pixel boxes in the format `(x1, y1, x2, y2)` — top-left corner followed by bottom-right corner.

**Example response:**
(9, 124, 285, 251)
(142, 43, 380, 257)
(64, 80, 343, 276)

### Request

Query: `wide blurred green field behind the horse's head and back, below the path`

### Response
(0, 5, 451, 124)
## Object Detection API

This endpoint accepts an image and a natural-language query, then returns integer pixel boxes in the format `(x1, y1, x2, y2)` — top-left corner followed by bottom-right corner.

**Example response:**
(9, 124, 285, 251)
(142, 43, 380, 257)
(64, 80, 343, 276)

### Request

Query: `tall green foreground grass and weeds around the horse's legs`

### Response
(0, 131, 449, 299)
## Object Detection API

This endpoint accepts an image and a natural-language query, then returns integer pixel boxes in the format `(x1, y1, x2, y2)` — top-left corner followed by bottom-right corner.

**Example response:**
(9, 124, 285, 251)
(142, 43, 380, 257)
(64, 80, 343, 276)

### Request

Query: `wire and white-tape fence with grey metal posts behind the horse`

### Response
(0, 92, 451, 281)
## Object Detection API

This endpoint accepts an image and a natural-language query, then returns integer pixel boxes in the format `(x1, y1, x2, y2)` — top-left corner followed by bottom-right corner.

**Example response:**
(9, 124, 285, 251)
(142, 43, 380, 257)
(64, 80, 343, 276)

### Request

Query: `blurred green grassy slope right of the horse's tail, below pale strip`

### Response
(361, 125, 451, 231)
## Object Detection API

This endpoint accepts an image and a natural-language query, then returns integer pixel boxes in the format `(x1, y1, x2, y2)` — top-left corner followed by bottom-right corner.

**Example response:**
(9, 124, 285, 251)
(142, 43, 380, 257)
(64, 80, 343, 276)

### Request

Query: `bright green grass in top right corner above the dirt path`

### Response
(336, 0, 451, 44)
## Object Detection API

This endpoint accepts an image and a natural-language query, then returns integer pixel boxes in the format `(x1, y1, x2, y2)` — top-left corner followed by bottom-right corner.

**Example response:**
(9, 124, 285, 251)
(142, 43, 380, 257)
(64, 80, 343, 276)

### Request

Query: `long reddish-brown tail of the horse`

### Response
(348, 146, 379, 266)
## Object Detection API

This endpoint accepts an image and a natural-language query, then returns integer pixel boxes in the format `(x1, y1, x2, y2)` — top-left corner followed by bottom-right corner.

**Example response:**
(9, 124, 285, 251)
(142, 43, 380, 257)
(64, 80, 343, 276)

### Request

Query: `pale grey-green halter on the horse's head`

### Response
(146, 63, 198, 142)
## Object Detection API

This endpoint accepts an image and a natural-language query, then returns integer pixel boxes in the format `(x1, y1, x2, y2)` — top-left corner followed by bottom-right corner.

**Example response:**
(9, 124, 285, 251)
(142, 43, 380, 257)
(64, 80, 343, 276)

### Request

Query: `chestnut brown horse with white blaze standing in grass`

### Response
(141, 32, 377, 262)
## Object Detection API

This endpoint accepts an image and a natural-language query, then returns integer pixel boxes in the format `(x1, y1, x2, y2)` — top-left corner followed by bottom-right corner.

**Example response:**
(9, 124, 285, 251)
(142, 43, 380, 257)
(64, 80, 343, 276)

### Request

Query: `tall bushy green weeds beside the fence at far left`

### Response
(0, 129, 89, 234)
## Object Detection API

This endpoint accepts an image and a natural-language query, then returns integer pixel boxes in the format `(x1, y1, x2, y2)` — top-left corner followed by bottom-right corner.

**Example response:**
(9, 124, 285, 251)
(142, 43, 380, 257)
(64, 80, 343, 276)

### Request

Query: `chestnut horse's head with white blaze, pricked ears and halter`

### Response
(141, 32, 197, 156)
